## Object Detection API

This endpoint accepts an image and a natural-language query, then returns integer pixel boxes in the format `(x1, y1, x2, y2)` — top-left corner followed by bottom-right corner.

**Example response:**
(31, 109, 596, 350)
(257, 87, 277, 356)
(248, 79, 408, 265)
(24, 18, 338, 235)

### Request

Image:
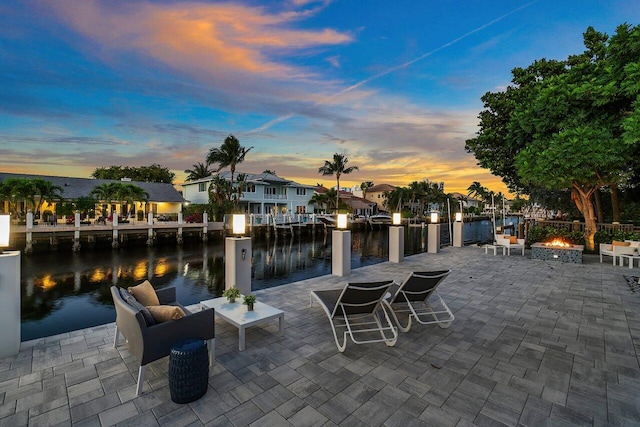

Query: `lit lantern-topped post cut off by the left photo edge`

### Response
(0, 215, 20, 358)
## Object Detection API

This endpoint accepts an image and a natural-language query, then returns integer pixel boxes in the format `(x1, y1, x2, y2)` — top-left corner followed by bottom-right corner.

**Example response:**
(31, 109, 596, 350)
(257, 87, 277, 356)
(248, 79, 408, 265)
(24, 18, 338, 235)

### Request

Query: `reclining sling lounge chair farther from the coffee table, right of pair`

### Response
(390, 270, 455, 332)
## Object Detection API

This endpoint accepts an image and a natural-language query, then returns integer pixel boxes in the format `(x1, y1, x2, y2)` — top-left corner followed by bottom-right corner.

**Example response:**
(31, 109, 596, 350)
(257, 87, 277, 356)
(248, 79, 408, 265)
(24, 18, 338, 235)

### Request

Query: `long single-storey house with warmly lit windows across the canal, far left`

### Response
(0, 172, 185, 219)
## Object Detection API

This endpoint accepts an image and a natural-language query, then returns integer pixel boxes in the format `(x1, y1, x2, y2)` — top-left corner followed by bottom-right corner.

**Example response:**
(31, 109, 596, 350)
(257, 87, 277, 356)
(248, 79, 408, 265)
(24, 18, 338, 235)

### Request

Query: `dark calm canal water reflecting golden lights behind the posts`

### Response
(21, 221, 490, 341)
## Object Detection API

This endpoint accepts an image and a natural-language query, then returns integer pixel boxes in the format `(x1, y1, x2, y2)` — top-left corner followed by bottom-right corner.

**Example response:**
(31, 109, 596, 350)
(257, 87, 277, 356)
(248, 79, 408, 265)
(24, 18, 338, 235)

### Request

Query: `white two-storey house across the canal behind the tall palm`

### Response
(182, 171, 314, 214)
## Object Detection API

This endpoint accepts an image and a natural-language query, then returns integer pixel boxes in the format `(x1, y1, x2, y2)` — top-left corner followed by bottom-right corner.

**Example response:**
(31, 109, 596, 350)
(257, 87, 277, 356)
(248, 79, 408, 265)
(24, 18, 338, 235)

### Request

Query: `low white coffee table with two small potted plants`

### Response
(200, 296, 284, 351)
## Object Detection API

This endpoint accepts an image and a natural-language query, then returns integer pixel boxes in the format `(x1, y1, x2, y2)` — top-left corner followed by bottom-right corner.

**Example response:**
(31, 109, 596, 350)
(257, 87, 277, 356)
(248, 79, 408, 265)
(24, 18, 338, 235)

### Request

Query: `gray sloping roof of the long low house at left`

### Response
(0, 172, 185, 203)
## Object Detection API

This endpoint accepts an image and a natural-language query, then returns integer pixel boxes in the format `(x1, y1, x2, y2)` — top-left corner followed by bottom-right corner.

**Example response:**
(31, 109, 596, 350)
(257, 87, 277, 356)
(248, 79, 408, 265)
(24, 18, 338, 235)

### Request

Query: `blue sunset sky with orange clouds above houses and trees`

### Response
(0, 0, 640, 193)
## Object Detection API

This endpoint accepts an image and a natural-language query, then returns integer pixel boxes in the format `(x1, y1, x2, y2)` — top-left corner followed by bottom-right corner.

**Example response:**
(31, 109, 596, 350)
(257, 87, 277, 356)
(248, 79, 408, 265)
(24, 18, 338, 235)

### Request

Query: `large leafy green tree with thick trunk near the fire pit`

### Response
(466, 24, 640, 249)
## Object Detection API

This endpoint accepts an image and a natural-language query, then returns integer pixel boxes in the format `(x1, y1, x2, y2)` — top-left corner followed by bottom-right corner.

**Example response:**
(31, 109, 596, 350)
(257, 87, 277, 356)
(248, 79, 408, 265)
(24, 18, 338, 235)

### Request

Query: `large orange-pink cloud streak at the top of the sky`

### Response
(51, 0, 352, 79)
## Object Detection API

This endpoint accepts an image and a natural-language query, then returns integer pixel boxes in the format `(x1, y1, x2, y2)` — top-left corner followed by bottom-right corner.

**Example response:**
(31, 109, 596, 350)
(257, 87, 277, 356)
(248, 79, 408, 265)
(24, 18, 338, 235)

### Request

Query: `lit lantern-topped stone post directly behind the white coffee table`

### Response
(224, 214, 252, 295)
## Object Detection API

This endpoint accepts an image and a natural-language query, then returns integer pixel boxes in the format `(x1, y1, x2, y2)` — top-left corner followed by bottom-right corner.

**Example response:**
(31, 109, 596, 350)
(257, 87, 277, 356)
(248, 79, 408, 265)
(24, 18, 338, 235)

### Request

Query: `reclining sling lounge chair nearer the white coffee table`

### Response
(309, 280, 398, 352)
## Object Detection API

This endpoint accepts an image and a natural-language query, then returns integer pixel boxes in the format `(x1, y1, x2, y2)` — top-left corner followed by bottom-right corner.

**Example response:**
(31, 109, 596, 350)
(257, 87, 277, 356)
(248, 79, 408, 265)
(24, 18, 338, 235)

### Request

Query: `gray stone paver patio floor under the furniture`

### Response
(0, 246, 640, 427)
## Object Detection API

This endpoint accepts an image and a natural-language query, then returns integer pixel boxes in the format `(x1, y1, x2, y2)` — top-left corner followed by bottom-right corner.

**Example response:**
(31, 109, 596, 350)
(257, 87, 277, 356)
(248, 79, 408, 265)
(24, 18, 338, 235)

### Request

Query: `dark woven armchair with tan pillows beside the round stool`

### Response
(111, 286, 215, 395)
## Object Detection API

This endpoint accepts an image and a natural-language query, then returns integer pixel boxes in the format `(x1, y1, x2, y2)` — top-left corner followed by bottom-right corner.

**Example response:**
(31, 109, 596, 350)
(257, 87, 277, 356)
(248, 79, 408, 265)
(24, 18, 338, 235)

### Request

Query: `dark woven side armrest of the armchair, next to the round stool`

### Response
(140, 308, 215, 365)
